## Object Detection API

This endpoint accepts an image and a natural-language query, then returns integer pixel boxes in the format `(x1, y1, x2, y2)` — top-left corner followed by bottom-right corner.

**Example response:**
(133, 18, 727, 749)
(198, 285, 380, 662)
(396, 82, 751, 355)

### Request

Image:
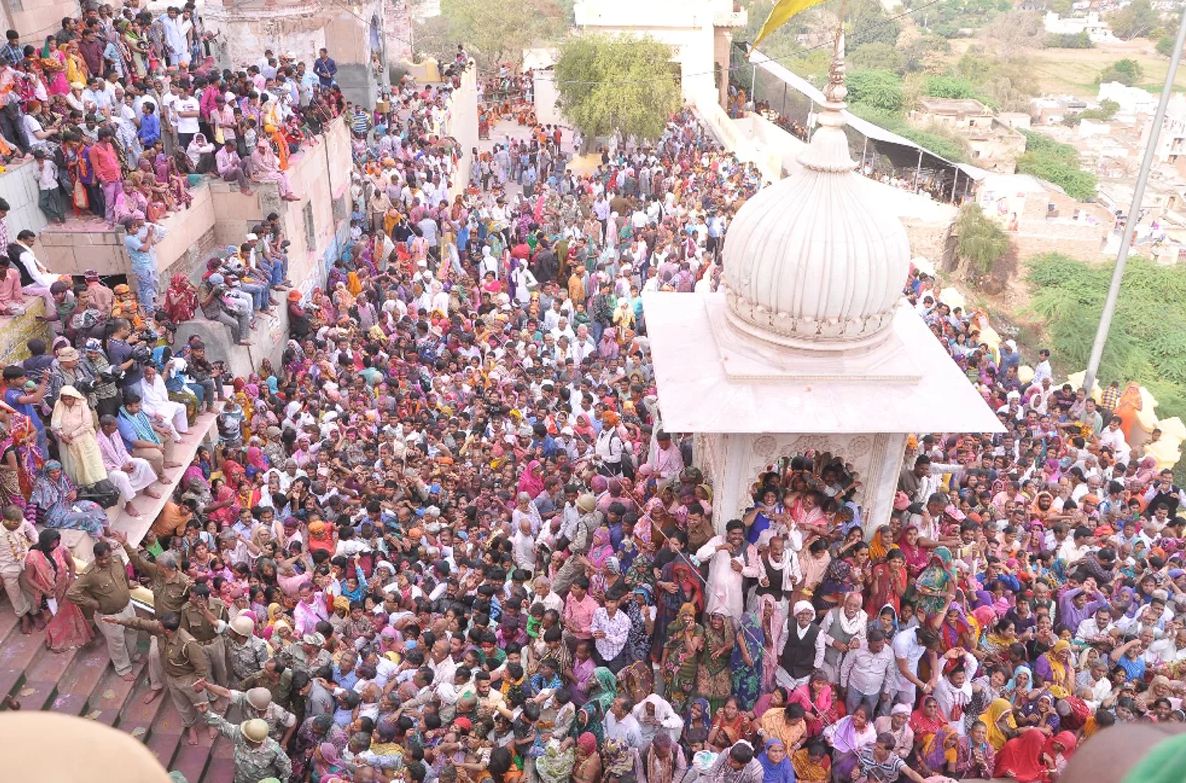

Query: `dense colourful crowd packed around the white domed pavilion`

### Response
(0, 9, 1186, 783)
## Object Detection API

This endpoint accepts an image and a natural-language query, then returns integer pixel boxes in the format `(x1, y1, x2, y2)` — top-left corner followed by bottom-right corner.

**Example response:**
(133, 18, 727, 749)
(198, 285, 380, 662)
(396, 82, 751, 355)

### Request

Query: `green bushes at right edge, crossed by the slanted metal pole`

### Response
(1026, 253, 1186, 418)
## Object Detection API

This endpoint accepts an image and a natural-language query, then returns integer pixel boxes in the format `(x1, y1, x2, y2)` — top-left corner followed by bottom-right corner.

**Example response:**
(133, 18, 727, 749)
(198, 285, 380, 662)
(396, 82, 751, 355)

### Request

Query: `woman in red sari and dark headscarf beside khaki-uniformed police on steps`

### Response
(24, 529, 93, 653)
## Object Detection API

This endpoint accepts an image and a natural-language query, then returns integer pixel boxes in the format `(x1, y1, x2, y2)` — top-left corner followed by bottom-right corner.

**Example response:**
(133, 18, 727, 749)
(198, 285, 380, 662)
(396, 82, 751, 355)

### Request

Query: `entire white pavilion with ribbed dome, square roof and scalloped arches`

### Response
(645, 41, 1002, 530)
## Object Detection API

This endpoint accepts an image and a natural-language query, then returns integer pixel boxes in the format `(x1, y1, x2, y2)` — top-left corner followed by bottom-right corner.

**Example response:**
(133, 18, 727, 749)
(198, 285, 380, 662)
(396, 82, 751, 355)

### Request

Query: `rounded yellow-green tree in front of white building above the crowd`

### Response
(554, 34, 681, 139)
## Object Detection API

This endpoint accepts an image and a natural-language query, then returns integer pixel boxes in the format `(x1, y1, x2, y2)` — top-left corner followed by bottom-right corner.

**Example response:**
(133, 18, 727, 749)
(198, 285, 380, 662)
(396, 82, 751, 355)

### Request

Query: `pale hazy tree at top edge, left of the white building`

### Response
(441, 0, 568, 65)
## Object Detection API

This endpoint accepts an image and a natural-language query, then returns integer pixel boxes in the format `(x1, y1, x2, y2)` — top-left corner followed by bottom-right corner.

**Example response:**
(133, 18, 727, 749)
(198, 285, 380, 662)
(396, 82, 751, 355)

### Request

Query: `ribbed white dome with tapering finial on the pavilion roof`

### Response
(722, 63, 910, 350)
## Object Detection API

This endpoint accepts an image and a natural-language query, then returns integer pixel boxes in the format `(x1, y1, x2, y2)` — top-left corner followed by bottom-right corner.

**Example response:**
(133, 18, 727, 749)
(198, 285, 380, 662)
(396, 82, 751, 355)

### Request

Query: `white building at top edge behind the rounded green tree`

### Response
(574, 0, 747, 104)
